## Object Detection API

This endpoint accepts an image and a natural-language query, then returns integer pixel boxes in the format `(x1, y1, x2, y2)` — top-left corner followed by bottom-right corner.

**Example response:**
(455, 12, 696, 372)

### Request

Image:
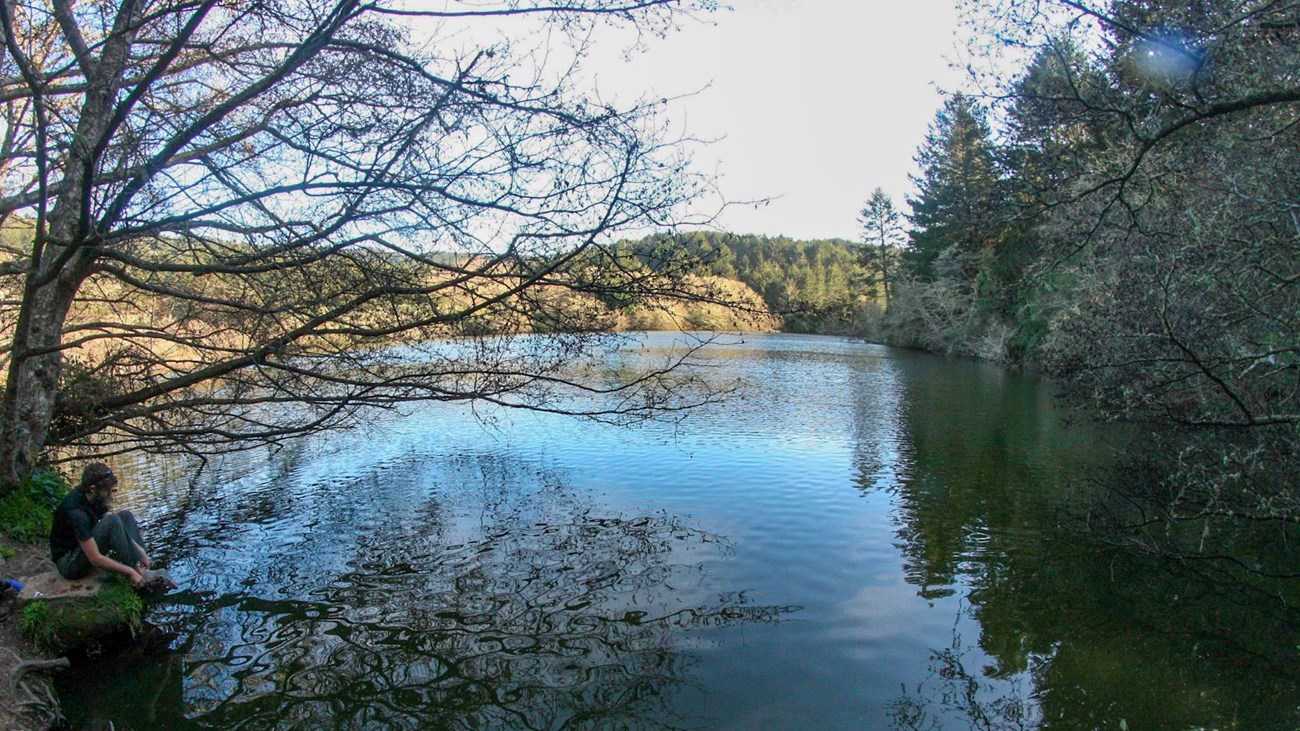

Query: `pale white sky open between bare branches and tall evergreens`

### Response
(590, 0, 961, 239)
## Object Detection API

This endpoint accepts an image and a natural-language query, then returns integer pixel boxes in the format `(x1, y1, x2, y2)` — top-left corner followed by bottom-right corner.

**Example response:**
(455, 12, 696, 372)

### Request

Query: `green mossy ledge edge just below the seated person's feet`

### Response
(20, 575, 144, 653)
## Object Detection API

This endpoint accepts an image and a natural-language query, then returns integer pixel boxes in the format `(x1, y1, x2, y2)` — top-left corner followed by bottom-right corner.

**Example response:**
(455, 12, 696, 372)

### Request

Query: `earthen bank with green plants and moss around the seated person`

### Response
(0, 468, 144, 731)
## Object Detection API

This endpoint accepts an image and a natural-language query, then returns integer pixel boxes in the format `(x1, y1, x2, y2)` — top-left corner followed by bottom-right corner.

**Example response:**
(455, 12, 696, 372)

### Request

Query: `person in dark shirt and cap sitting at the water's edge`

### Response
(49, 462, 176, 589)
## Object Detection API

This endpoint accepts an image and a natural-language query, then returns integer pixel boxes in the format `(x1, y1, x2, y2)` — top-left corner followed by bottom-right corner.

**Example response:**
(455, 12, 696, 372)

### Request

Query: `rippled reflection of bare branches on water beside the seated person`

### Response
(89, 455, 796, 728)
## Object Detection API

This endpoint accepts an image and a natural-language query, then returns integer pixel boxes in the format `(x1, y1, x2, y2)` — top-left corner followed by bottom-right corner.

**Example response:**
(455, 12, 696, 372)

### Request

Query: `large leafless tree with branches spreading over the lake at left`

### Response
(0, 0, 728, 485)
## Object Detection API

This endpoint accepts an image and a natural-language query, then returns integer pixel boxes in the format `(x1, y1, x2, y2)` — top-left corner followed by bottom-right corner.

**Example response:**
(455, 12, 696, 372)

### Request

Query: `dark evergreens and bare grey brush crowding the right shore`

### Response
(874, 0, 1300, 587)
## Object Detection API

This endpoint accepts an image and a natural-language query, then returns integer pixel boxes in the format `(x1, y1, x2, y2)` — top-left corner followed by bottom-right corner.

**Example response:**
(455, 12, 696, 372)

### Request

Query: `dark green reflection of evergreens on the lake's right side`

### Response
(859, 360, 1300, 728)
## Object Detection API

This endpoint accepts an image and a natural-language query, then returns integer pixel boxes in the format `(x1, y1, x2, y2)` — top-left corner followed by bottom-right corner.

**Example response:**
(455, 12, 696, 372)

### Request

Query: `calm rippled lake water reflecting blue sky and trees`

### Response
(61, 336, 1300, 730)
